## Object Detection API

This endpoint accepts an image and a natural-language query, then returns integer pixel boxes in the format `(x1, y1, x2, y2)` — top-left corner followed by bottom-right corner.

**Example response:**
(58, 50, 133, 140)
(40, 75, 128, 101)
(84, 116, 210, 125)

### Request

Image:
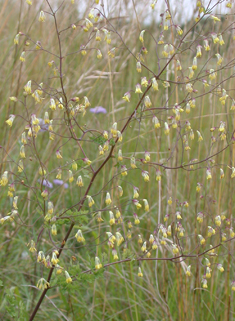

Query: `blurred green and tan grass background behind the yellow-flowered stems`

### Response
(0, 0, 235, 321)
